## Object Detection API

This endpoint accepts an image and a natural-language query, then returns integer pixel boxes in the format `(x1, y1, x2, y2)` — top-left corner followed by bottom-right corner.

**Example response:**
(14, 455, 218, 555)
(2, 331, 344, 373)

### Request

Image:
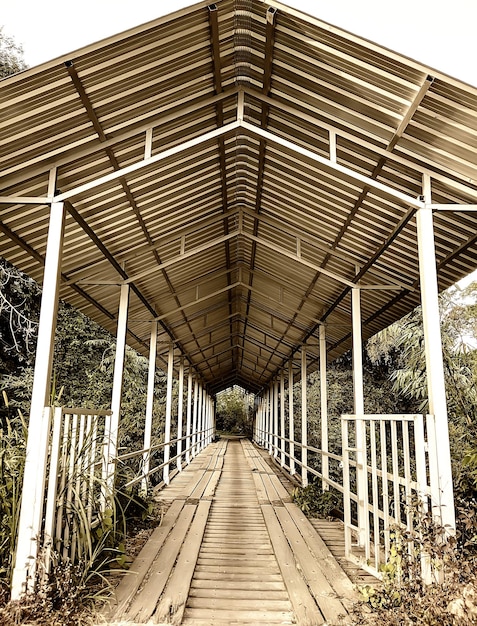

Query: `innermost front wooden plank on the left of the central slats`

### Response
(154, 500, 211, 625)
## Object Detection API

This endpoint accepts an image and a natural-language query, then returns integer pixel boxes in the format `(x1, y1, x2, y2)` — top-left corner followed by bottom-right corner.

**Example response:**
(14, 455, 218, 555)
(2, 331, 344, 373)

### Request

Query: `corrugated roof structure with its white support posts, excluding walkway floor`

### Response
(0, 0, 477, 616)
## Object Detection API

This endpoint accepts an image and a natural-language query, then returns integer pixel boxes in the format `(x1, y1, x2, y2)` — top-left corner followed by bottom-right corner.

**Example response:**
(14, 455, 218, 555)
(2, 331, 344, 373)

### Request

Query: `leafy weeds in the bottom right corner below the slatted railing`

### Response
(355, 505, 477, 626)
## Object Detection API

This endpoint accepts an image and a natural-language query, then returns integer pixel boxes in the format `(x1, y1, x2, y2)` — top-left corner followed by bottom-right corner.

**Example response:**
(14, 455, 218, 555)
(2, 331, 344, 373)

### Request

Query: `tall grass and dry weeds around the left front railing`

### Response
(0, 392, 152, 626)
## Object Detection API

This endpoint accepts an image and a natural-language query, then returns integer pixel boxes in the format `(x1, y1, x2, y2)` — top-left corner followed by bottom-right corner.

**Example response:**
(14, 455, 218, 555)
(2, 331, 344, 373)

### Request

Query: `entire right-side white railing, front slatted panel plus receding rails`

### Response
(254, 414, 438, 578)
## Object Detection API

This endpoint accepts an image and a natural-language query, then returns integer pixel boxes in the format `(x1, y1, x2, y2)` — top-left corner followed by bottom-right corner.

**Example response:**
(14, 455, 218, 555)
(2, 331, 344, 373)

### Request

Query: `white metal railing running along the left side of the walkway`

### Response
(14, 407, 214, 597)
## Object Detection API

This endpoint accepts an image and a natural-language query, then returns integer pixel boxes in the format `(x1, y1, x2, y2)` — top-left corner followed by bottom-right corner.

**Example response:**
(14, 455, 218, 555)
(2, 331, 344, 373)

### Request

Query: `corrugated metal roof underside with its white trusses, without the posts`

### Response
(0, 0, 477, 393)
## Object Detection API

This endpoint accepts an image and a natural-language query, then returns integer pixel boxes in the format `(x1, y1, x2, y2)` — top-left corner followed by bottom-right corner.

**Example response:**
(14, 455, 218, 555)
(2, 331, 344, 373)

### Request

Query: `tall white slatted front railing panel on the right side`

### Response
(342, 414, 434, 578)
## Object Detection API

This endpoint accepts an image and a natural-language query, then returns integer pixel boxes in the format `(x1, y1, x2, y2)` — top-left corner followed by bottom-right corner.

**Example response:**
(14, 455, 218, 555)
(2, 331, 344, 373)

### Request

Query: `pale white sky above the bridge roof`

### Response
(0, 0, 477, 86)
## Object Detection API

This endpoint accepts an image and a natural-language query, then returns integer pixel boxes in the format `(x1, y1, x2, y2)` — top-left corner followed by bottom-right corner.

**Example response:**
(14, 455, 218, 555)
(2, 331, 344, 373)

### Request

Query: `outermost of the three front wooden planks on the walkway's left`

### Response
(108, 500, 184, 619)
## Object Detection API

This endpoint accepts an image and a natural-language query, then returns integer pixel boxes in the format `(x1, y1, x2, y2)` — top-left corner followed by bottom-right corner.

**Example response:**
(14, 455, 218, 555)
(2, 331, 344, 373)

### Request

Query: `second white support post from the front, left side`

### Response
(102, 285, 129, 500)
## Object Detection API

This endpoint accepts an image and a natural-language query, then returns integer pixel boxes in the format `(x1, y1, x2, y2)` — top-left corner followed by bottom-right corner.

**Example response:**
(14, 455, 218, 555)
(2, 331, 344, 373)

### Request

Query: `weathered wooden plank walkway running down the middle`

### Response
(104, 439, 356, 626)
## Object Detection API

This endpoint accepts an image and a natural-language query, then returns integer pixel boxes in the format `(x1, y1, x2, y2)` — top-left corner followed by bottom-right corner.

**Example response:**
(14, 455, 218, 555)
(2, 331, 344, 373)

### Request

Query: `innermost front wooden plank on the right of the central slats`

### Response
(261, 504, 324, 626)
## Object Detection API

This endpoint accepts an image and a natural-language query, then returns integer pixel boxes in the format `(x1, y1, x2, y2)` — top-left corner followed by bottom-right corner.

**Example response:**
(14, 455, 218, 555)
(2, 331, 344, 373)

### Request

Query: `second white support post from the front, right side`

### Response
(352, 287, 369, 546)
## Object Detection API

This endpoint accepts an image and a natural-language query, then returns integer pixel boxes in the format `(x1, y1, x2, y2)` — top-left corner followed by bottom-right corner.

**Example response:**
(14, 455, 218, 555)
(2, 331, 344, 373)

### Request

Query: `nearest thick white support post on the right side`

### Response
(416, 175, 455, 533)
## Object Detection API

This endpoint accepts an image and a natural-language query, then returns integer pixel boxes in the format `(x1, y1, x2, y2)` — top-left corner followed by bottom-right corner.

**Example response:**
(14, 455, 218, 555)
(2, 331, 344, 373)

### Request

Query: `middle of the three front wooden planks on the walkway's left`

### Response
(124, 504, 197, 622)
